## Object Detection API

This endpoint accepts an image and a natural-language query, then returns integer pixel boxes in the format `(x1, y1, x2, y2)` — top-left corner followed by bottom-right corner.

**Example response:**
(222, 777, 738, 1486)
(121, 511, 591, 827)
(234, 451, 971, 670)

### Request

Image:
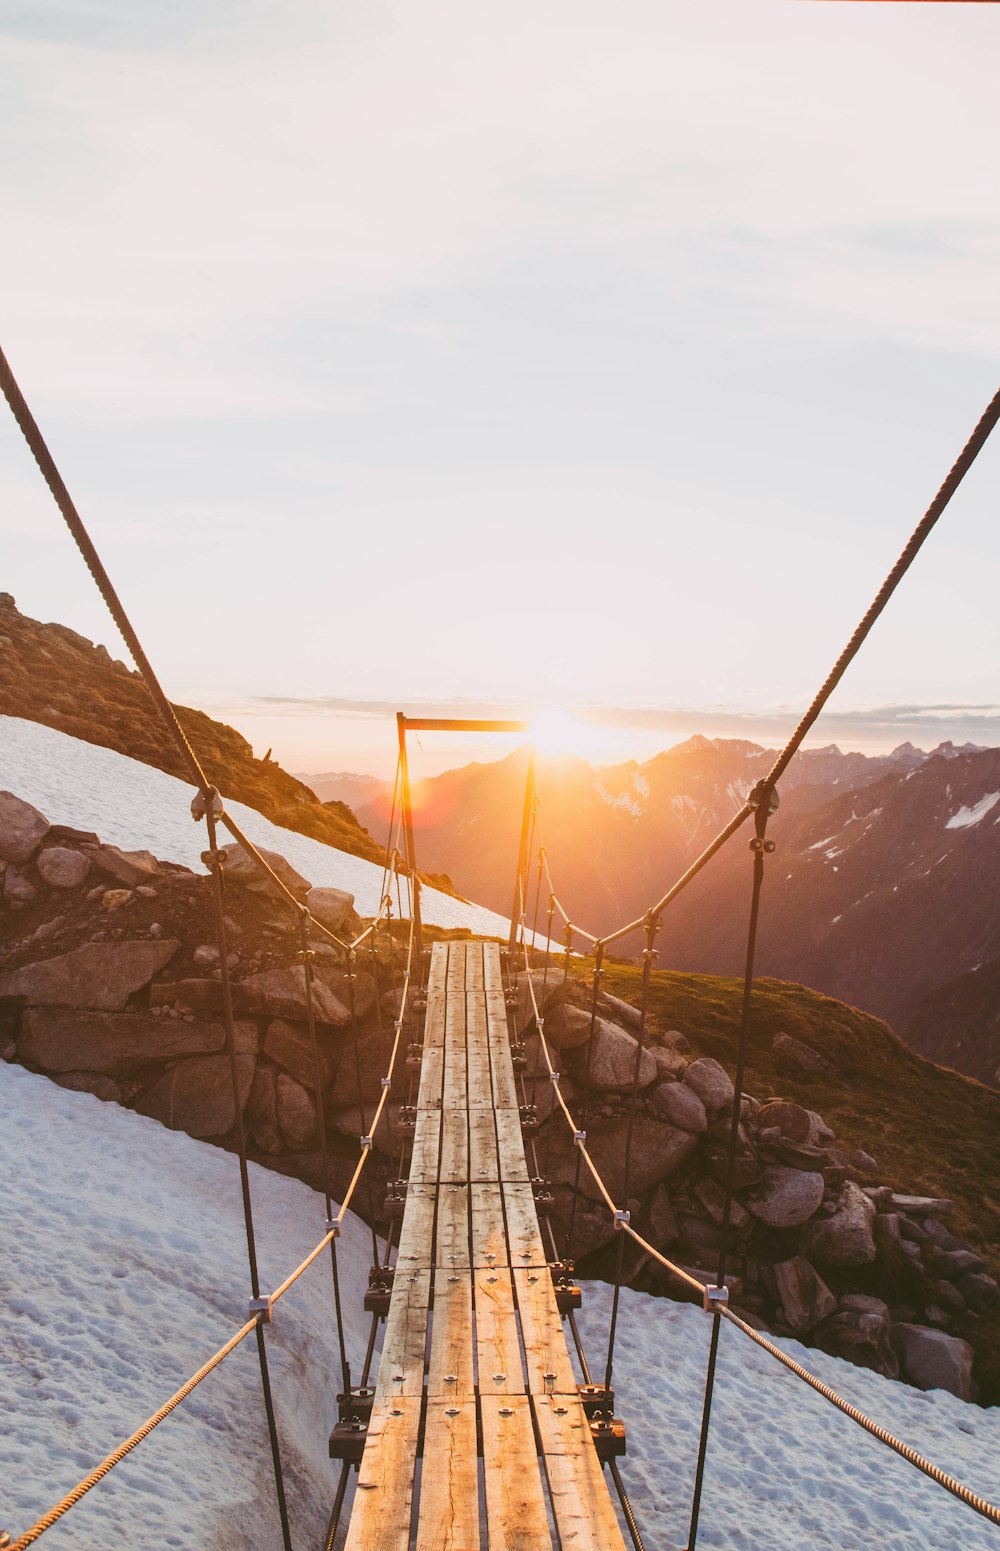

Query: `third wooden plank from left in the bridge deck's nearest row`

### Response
(481, 1394, 552, 1551)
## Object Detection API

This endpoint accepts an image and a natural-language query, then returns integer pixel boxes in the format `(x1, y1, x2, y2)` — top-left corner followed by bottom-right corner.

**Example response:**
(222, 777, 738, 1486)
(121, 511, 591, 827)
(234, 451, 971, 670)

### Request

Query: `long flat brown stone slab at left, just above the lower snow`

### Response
(17, 1007, 226, 1076)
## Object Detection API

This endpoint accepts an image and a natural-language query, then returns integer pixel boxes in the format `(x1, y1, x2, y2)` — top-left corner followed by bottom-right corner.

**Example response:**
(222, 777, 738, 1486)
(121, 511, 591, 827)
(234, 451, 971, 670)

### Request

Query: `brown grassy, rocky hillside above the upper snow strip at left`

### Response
(0, 592, 381, 861)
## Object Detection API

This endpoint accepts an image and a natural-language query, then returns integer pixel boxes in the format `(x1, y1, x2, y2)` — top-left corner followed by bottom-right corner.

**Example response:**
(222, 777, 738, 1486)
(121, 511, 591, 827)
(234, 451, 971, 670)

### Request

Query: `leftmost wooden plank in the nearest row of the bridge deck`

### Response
(344, 1396, 422, 1551)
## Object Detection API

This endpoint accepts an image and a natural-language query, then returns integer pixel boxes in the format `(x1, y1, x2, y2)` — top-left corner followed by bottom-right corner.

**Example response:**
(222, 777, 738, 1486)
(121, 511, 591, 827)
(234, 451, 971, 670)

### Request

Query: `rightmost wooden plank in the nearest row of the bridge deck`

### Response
(532, 1394, 625, 1551)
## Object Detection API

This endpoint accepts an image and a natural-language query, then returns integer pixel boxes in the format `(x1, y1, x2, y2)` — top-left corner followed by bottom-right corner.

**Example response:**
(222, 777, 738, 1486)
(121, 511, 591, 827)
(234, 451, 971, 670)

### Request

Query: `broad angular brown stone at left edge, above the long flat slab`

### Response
(0, 938, 180, 1013)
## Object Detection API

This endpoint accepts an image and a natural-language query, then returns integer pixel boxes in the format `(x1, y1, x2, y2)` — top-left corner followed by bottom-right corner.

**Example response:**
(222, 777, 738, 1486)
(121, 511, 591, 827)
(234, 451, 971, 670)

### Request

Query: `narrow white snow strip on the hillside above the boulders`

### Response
(0, 717, 513, 937)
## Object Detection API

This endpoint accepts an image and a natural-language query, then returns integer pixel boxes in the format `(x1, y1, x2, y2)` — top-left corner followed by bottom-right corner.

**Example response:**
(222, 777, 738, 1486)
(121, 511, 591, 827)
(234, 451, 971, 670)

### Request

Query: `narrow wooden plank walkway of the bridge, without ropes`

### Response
(346, 943, 625, 1551)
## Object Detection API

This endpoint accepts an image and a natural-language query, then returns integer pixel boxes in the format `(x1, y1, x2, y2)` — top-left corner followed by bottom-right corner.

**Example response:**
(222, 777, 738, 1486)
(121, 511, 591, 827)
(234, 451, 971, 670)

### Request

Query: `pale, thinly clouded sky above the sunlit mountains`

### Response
(0, 0, 1000, 776)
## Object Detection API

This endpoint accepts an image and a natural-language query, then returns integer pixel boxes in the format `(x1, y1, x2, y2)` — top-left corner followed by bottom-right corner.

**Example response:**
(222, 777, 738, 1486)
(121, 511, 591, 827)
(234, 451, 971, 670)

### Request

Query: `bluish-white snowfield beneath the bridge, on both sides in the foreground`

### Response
(0, 1064, 1000, 1551)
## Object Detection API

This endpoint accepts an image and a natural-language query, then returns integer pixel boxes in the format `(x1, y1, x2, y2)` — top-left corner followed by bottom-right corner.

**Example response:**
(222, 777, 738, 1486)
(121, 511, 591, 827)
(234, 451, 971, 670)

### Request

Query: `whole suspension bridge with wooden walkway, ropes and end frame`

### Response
(0, 342, 1000, 1551)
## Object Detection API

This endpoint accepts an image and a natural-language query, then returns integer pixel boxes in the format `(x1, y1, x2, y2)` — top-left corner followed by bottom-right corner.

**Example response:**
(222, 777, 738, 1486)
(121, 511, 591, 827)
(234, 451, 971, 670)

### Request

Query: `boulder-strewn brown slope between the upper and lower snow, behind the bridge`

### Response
(0, 794, 1000, 1401)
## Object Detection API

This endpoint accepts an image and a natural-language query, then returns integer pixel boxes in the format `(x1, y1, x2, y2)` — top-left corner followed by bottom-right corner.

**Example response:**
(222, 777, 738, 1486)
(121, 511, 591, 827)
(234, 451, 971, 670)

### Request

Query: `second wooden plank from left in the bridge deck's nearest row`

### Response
(417, 1396, 479, 1551)
